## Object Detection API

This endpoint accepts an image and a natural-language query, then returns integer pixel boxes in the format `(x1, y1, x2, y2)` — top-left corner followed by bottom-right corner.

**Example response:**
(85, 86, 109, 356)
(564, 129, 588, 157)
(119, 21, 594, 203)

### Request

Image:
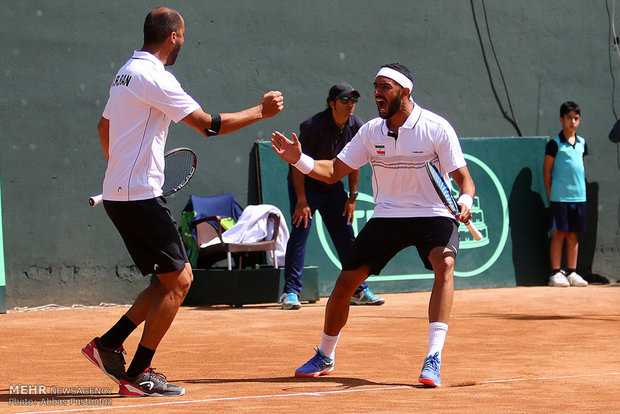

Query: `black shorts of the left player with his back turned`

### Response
(103, 197, 189, 275)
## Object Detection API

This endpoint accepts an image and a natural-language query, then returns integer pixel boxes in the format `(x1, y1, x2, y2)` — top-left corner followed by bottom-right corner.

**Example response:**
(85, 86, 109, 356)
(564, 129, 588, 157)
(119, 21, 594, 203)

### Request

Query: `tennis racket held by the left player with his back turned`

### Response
(88, 148, 198, 207)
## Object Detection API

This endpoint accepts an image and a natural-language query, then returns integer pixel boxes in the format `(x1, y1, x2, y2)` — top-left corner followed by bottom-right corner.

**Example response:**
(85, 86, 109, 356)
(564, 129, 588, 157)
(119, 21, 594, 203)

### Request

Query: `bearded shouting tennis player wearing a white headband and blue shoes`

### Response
(271, 63, 475, 387)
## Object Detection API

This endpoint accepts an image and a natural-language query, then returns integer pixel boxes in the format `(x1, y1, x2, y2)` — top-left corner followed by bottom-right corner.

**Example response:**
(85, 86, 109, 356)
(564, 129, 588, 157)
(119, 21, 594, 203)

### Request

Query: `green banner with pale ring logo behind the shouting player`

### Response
(256, 137, 548, 295)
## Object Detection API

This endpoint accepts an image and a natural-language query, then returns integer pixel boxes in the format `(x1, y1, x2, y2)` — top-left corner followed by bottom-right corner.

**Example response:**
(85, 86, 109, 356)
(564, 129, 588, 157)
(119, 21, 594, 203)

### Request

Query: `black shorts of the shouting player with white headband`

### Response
(342, 217, 459, 275)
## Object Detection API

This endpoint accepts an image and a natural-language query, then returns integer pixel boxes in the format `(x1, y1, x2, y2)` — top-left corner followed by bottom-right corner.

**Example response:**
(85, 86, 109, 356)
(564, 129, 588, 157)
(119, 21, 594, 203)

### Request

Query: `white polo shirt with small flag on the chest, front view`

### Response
(338, 103, 466, 218)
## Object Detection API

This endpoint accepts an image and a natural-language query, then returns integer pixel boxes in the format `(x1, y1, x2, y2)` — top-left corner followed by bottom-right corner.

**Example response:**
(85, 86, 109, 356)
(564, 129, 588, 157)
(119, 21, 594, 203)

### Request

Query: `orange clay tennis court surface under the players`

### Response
(0, 284, 620, 413)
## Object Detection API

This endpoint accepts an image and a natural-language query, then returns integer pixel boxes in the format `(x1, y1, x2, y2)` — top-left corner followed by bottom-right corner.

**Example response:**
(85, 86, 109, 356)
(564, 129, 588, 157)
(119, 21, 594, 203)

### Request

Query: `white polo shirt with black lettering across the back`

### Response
(103, 51, 200, 201)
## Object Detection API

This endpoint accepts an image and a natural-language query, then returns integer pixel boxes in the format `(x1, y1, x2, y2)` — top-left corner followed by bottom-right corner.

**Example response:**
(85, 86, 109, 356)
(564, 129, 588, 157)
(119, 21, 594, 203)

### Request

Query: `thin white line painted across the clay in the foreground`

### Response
(22, 372, 620, 414)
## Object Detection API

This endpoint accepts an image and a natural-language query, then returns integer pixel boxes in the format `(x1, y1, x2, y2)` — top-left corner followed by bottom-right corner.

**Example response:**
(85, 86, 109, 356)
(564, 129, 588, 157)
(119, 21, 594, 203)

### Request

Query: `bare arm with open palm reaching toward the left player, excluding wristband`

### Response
(271, 131, 355, 184)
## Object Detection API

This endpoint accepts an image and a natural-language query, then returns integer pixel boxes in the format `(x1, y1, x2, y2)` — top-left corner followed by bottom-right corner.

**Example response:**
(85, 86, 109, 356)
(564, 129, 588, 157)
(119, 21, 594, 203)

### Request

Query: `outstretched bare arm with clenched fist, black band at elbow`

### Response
(182, 91, 284, 136)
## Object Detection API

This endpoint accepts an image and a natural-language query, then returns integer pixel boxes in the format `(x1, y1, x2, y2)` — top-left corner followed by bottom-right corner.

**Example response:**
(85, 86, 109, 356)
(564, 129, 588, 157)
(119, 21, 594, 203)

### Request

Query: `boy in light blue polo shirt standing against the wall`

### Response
(543, 101, 588, 287)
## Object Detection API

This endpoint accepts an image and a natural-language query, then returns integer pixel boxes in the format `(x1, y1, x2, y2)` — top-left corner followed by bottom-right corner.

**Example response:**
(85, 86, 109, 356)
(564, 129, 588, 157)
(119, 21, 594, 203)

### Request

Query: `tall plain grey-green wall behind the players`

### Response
(0, 0, 620, 308)
